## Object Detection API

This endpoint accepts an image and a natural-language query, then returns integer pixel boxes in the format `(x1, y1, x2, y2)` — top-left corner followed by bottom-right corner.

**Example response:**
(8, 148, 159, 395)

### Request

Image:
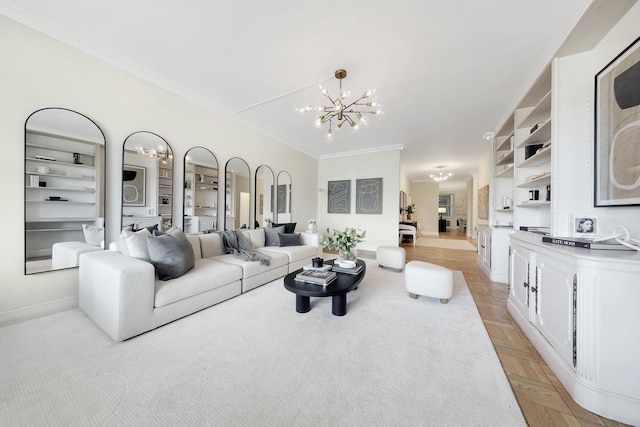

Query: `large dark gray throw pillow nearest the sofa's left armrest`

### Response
(147, 227, 196, 280)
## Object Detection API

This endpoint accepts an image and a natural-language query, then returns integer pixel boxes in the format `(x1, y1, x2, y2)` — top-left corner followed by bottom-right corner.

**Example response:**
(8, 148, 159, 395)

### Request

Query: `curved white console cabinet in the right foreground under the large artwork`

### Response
(507, 232, 640, 425)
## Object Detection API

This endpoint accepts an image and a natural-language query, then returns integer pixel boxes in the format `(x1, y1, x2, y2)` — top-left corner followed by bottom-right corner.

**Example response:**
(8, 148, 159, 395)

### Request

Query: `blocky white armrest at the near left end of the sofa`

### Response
(78, 251, 155, 341)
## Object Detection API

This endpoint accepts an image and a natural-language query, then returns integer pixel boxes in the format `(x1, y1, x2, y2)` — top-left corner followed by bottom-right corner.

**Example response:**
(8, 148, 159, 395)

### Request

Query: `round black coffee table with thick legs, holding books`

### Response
(284, 259, 367, 316)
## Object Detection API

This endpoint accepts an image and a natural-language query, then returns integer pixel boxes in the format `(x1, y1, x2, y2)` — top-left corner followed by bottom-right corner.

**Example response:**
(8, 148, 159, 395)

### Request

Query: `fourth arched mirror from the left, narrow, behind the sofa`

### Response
(224, 157, 251, 230)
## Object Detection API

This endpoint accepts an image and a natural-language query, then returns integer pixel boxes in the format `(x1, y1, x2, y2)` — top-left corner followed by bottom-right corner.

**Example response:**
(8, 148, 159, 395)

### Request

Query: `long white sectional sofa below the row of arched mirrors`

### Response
(79, 229, 319, 341)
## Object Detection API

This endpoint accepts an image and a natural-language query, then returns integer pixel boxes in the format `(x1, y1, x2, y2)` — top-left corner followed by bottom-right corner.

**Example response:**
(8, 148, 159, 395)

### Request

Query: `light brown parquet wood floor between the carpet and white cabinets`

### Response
(400, 231, 625, 427)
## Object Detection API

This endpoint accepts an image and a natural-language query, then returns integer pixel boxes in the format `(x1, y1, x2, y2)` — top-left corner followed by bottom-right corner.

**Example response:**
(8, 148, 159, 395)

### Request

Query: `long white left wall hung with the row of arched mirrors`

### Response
(0, 16, 318, 325)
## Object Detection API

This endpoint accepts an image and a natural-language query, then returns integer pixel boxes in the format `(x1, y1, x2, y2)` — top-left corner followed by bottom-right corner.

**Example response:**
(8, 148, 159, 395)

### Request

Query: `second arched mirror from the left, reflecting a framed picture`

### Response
(122, 131, 173, 234)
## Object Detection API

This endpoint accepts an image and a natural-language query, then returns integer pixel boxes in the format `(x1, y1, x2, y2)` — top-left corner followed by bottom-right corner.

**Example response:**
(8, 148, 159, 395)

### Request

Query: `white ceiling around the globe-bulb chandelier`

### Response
(0, 0, 591, 187)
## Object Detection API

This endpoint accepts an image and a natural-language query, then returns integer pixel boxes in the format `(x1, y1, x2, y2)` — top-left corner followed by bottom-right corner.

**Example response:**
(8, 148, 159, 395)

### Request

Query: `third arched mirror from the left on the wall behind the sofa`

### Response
(182, 147, 219, 233)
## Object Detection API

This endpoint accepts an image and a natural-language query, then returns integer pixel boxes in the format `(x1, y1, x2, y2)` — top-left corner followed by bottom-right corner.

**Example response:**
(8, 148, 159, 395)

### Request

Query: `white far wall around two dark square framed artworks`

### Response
(318, 149, 400, 251)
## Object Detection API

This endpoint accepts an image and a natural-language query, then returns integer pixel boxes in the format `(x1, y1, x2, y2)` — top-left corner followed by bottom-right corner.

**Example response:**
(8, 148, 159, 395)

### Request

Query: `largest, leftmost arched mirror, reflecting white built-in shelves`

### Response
(24, 108, 105, 274)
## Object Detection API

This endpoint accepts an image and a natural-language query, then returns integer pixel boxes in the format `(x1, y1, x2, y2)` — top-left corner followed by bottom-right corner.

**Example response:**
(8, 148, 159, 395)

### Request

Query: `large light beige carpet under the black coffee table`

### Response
(0, 260, 526, 427)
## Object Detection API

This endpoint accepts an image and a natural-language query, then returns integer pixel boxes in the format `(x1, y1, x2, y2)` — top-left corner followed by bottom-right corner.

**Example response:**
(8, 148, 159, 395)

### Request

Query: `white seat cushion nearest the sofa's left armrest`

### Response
(154, 258, 242, 307)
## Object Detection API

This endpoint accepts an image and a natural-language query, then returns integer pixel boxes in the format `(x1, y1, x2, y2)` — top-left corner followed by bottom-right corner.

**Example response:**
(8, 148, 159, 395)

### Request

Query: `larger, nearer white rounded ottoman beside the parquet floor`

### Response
(404, 261, 453, 304)
